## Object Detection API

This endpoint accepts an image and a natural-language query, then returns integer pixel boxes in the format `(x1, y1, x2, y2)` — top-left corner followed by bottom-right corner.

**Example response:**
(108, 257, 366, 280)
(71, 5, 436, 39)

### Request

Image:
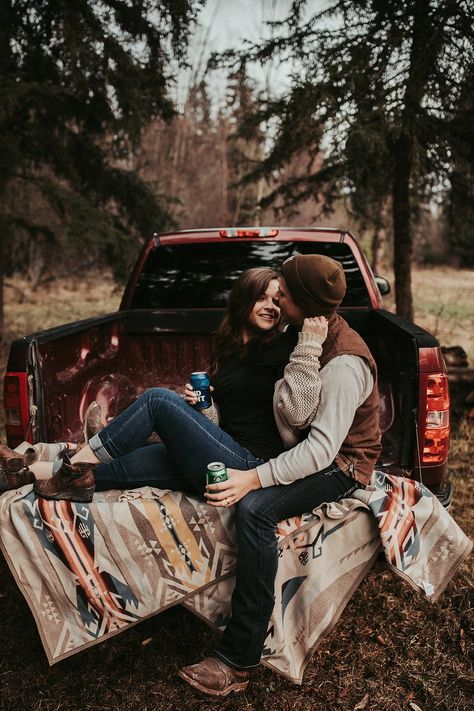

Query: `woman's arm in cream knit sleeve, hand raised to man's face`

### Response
(273, 316, 328, 447)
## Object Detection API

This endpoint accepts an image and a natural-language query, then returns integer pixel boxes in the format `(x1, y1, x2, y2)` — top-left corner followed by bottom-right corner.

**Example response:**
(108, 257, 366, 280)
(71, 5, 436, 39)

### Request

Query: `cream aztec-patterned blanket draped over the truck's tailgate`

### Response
(0, 472, 472, 683)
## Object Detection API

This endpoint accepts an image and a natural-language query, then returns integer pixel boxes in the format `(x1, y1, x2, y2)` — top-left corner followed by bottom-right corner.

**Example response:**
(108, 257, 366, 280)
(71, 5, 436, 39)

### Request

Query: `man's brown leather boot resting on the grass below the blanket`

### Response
(178, 657, 250, 696)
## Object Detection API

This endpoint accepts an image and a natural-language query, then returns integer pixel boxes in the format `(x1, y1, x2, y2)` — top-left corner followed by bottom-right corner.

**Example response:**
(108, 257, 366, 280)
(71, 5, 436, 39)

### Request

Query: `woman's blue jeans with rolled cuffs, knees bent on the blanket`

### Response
(89, 388, 263, 494)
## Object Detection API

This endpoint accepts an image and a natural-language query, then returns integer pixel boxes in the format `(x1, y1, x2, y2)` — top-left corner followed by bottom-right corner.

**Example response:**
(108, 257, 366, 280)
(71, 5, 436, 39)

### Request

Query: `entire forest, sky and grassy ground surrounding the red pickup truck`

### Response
(0, 0, 474, 711)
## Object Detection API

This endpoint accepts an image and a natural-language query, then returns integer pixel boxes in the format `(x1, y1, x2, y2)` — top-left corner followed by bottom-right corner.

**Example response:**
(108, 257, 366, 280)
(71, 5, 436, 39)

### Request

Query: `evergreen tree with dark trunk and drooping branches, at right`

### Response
(223, 0, 474, 319)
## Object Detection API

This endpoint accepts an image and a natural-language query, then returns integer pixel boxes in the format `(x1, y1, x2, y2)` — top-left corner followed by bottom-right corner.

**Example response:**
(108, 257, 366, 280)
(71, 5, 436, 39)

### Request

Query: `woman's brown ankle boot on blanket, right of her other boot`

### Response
(34, 455, 95, 503)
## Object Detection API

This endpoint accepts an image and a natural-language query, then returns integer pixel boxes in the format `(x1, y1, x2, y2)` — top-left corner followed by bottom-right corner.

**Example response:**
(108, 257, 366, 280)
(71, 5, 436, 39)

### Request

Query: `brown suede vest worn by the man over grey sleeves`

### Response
(320, 314, 381, 484)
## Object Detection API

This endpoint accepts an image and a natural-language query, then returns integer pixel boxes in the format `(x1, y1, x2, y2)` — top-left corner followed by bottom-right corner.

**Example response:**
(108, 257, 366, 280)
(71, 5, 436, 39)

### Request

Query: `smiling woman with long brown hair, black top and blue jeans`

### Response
(1, 268, 319, 506)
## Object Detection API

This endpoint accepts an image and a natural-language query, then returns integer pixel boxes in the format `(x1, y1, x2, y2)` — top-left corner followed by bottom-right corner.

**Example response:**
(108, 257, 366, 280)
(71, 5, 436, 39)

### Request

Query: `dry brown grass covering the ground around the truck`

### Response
(0, 270, 474, 711)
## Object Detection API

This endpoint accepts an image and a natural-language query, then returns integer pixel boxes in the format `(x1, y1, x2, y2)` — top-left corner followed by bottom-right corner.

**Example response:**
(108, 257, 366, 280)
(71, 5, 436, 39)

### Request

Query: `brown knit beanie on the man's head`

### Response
(281, 254, 346, 316)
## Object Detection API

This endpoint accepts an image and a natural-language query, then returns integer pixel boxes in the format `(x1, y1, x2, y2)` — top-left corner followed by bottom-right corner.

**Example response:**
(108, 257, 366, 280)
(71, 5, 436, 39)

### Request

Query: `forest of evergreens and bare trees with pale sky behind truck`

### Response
(0, 0, 474, 333)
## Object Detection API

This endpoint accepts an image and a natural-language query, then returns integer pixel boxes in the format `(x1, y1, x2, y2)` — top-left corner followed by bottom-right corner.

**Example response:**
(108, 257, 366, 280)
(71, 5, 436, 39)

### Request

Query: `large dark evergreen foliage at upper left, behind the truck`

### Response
(0, 0, 201, 334)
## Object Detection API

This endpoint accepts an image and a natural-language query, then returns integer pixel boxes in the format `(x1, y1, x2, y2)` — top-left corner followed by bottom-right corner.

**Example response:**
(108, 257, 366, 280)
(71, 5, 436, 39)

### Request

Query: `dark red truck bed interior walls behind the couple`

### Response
(8, 309, 437, 490)
